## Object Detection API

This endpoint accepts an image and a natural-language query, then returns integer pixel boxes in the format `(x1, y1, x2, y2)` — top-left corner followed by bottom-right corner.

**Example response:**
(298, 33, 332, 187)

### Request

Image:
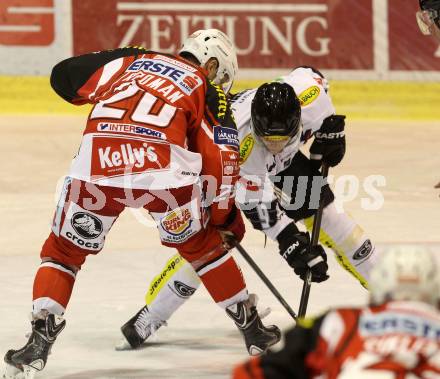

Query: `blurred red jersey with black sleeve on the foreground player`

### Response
(234, 301, 440, 379)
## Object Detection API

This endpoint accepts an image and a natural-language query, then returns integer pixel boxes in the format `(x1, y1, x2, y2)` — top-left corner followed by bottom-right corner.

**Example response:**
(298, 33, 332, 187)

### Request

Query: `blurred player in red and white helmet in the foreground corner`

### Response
(233, 248, 440, 379)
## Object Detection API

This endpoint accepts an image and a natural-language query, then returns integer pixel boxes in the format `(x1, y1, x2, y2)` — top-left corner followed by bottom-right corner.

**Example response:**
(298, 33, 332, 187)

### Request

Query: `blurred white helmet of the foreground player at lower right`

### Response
(369, 246, 440, 305)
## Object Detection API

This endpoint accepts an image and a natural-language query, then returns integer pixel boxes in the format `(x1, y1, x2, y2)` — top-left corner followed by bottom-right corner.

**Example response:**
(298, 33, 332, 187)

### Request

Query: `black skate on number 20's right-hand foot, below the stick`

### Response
(226, 294, 281, 355)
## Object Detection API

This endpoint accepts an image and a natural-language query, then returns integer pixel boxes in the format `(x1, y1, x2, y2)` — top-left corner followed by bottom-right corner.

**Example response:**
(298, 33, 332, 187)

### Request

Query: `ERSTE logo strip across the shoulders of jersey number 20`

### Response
(127, 56, 203, 95)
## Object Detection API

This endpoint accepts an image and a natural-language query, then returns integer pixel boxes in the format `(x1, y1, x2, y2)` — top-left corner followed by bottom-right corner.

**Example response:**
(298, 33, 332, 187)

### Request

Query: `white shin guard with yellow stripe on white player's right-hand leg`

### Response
(304, 203, 376, 288)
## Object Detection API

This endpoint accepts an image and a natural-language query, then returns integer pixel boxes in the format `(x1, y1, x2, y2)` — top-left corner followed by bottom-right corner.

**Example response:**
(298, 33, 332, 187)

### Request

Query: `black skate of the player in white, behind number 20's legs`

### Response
(116, 305, 167, 350)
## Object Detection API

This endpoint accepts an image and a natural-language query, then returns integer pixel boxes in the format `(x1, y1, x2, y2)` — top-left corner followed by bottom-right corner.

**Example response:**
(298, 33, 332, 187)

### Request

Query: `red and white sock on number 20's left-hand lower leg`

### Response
(33, 261, 76, 316)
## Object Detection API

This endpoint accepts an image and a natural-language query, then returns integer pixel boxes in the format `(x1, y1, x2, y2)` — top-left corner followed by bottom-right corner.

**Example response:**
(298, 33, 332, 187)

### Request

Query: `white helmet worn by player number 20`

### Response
(179, 29, 238, 93)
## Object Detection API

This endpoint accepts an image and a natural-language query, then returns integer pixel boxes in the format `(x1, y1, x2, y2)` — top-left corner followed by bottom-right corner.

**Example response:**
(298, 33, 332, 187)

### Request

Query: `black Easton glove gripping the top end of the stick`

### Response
(310, 115, 345, 170)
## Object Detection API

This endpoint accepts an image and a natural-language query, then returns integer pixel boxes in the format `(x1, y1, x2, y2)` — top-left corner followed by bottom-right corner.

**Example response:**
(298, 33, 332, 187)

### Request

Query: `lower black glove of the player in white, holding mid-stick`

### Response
(277, 223, 329, 283)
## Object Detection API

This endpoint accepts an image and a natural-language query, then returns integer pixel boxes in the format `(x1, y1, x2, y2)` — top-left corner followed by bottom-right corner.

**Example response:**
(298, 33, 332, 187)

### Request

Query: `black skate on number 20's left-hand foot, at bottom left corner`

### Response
(5, 314, 66, 379)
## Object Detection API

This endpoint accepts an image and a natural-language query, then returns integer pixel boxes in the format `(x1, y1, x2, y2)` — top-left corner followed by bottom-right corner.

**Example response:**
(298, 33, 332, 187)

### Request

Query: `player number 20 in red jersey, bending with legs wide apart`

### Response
(1, 29, 280, 378)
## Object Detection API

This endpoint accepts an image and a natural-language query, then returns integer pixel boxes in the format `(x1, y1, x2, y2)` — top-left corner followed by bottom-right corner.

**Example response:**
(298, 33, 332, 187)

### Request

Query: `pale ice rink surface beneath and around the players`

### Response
(0, 116, 440, 379)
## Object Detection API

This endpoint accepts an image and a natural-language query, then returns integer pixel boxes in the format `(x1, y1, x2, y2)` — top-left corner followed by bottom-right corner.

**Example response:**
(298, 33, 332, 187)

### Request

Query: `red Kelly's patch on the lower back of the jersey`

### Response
(91, 136, 171, 177)
